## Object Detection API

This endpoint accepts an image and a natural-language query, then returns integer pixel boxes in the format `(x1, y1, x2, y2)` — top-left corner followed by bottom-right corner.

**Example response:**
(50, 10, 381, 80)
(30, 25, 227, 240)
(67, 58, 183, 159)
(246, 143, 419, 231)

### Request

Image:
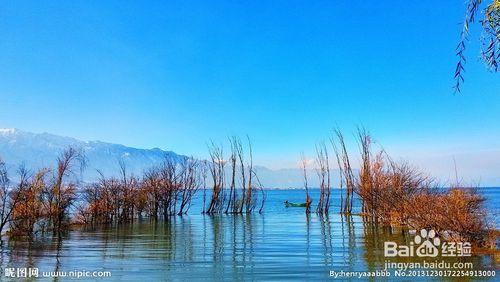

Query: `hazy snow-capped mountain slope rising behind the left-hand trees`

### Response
(0, 129, 185, 180)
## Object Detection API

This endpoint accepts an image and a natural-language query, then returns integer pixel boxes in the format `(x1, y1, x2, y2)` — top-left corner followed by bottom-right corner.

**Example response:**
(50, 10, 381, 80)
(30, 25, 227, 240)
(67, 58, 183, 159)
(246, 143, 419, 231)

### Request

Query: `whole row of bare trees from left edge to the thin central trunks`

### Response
(0, 137, 265, 236)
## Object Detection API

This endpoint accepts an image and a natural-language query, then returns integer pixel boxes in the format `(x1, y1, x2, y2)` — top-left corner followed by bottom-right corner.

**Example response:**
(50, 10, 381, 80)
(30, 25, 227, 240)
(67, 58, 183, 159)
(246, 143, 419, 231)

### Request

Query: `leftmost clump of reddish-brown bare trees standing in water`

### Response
(6, 147, 85, 236)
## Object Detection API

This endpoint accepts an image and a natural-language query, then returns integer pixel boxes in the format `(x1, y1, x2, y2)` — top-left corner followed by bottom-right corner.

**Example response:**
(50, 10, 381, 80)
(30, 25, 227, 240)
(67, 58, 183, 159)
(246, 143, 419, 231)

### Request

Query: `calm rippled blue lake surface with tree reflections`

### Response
(0, 188, 500, 281)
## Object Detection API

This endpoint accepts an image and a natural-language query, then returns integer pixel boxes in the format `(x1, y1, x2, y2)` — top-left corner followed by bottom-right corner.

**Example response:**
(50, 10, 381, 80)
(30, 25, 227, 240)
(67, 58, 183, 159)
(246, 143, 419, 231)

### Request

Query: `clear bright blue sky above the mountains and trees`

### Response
(0, 0, 500, 183)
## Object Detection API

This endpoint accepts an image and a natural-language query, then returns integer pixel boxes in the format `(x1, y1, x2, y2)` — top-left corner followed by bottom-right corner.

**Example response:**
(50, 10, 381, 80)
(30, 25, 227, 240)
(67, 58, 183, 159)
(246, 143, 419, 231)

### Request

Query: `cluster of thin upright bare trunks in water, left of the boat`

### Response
(203, 137, 265, 214)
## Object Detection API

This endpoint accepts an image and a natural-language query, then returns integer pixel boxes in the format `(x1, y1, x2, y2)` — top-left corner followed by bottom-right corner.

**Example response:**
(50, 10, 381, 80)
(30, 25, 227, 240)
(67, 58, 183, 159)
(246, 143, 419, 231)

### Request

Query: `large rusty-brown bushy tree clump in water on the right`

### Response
(330, 129, 494, 246)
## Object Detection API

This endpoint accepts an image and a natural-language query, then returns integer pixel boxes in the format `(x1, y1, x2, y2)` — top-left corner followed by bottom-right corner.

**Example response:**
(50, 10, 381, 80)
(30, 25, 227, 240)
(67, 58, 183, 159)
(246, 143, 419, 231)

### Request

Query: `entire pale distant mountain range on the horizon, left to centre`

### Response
(0, 129, 338, 188)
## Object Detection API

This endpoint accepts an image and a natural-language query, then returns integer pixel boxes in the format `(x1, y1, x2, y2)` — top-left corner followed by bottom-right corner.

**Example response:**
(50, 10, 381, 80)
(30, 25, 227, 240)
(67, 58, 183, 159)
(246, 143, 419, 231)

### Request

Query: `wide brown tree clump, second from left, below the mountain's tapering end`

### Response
(77, 158, 202, 224)
